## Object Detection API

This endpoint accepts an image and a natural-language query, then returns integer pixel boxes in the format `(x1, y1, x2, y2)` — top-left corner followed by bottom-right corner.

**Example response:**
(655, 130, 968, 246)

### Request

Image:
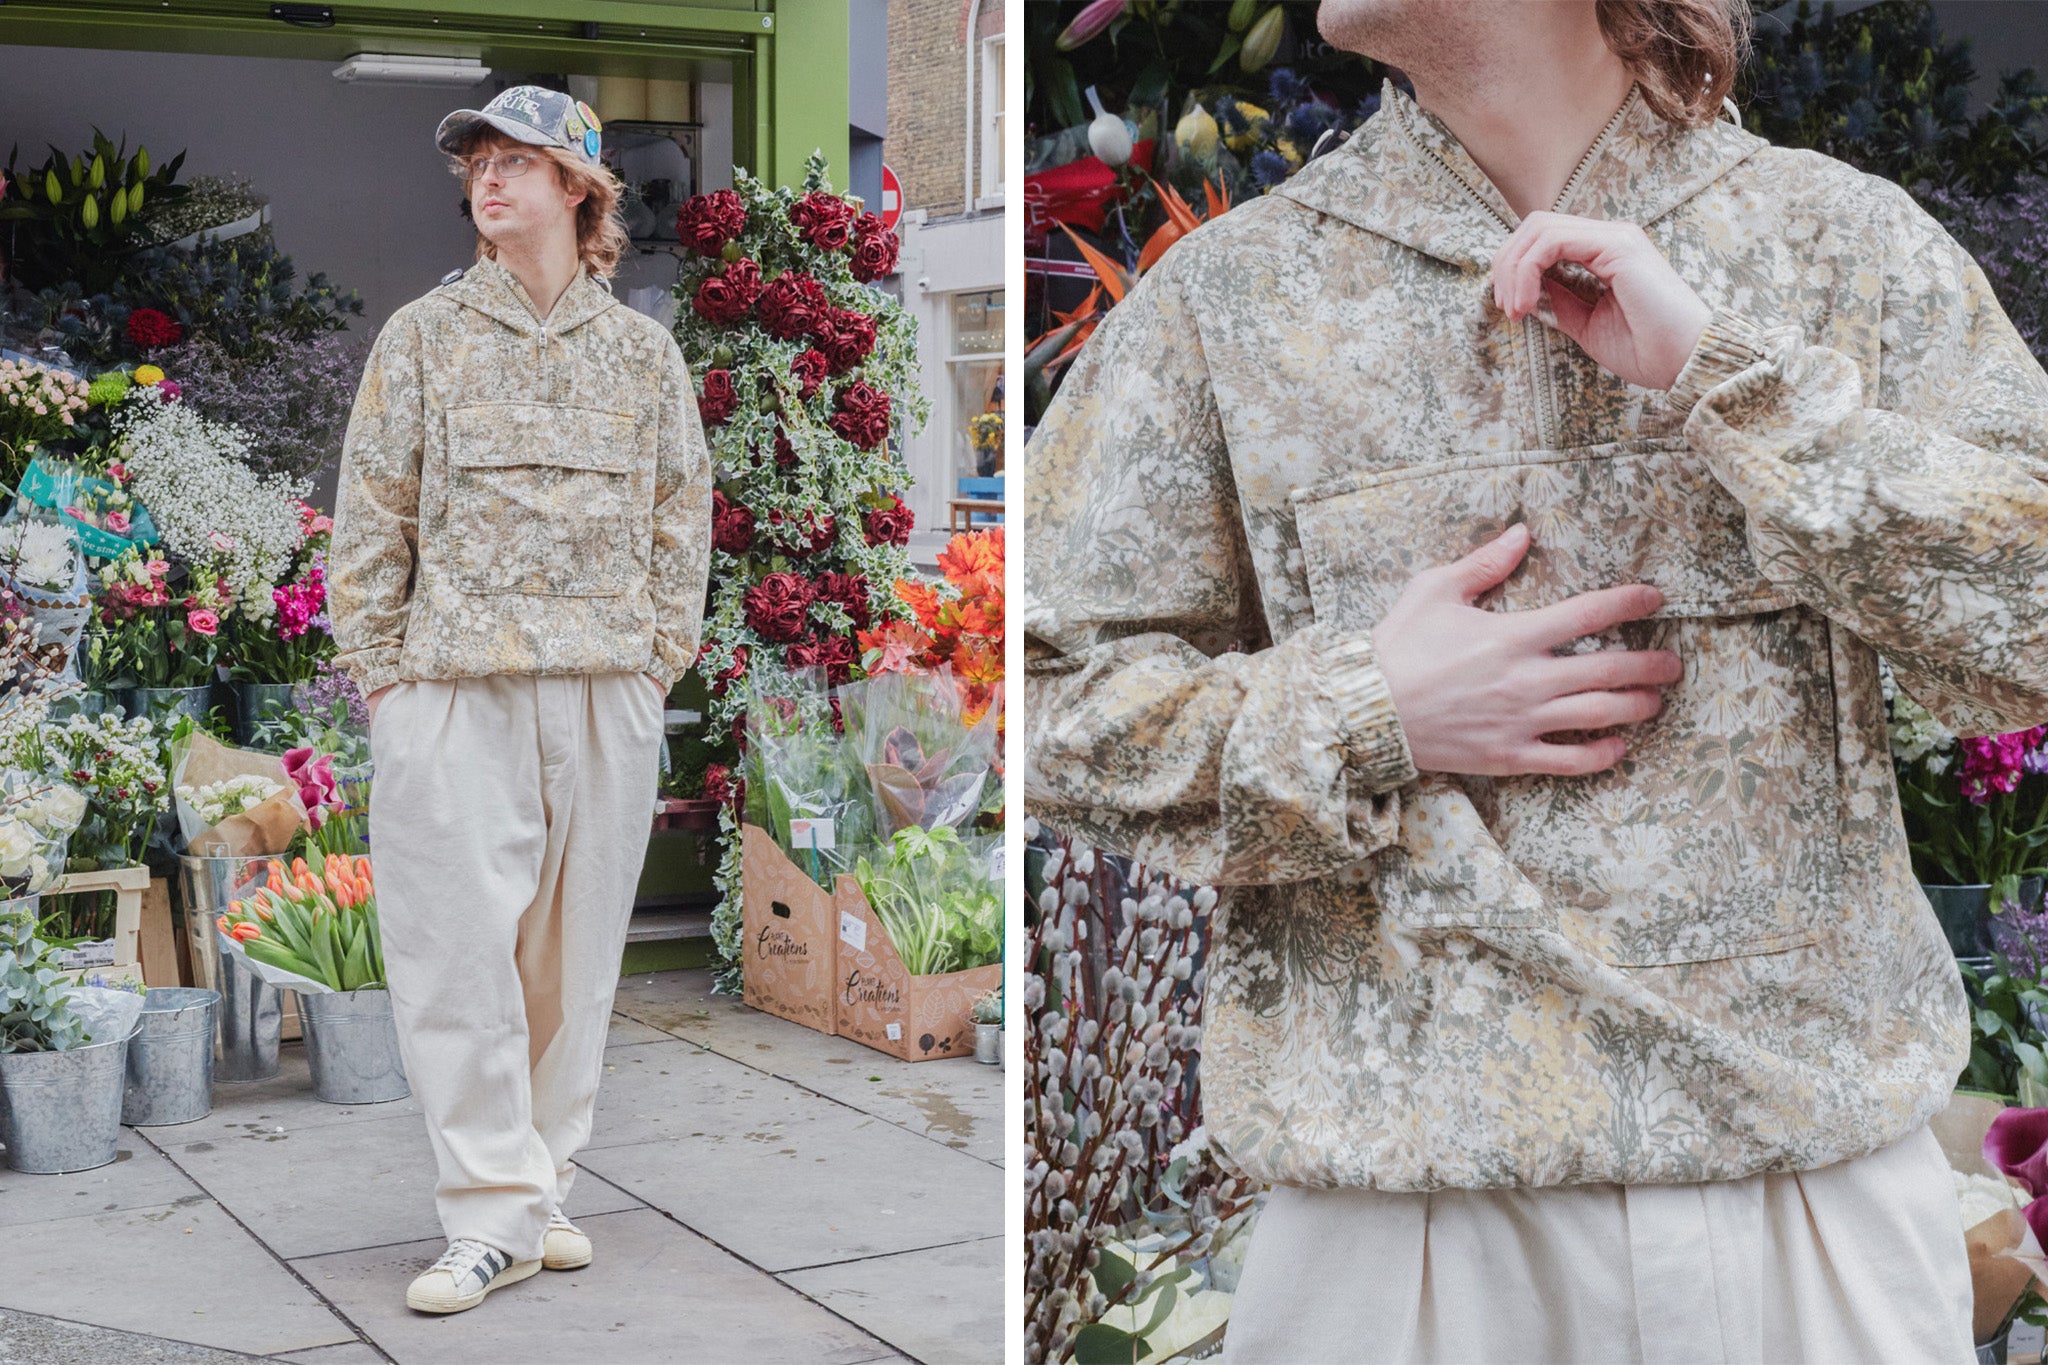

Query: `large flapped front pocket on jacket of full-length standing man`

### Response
(440, 403, 653, 598)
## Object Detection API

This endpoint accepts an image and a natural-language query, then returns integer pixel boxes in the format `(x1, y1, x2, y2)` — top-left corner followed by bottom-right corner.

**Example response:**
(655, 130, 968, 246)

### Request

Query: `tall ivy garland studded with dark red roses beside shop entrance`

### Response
(676, 151, 930, 993)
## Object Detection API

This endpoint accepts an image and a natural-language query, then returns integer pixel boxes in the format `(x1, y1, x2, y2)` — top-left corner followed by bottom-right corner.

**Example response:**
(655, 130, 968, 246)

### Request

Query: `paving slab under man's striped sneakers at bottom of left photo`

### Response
(293, 1209, 891, 1365)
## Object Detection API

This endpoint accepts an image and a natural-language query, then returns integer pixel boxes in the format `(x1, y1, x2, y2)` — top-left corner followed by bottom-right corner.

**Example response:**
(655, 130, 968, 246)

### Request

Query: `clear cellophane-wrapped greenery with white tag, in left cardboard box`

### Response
(743, 667, 874, 890)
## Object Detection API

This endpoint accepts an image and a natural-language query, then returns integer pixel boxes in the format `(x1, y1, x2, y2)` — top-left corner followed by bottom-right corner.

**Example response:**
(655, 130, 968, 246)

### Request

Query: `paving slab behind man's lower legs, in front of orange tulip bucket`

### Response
(150, 1113, 637, 1259)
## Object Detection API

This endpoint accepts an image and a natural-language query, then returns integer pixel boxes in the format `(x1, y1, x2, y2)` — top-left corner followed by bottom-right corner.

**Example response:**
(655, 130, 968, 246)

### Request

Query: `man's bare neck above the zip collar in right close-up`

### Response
(1407, 21, 1632, 217)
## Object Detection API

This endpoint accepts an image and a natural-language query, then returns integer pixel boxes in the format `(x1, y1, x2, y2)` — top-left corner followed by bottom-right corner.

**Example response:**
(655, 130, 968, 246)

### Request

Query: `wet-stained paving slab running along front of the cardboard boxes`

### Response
(616, 972, 1004, 1164)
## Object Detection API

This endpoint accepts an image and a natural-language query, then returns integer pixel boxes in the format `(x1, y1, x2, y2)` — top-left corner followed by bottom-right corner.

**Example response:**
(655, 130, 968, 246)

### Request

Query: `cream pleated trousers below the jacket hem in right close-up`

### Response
(1223, 1128, 1974, 1365)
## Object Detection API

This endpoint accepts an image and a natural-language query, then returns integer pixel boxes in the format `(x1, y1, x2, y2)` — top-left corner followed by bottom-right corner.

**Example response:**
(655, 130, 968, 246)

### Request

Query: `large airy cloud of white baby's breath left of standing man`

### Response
(117, 387, 307, 620)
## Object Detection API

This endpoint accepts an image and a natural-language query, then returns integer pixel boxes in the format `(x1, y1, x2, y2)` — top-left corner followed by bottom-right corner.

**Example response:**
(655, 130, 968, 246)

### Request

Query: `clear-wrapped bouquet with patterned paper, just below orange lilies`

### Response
(840, 667, 997, 839)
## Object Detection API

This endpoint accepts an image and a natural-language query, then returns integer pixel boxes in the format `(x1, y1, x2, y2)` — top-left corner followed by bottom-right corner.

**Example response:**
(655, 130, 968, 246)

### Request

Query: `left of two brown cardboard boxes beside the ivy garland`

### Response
(739, 825, 838, 1033)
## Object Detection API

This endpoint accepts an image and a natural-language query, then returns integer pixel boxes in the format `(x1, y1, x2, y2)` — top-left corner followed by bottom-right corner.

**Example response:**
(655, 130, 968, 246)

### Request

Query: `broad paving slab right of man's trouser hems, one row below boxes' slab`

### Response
(580, 1072, 1004, 1277)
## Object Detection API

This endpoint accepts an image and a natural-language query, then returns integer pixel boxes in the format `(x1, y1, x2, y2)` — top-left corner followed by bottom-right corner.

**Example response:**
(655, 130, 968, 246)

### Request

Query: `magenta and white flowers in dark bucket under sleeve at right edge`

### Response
(1882, 667, 2048, 958)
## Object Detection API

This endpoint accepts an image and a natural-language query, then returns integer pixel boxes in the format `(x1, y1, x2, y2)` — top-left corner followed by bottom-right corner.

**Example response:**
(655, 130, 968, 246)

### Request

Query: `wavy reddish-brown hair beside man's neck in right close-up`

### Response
(1593, 0, 1753, 127)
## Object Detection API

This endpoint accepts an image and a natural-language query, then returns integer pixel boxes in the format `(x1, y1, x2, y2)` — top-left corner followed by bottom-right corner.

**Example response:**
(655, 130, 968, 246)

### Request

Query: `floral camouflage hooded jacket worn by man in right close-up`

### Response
(1024, 82, 2048, 1191)
